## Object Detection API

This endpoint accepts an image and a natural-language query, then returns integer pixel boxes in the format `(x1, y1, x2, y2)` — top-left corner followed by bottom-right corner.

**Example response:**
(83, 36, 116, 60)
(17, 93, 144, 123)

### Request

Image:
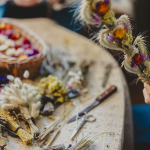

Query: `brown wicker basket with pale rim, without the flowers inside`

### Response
(0, 18, 48, 79)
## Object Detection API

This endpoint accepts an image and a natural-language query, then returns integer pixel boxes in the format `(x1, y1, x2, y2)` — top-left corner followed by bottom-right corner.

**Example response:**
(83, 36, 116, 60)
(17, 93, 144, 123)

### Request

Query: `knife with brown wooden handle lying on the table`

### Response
(68, 86, 117, 123)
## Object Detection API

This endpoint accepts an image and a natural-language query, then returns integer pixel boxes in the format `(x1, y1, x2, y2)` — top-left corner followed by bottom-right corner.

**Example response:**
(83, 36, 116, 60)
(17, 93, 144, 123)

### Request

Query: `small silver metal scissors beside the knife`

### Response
(70, 114, 96, 140)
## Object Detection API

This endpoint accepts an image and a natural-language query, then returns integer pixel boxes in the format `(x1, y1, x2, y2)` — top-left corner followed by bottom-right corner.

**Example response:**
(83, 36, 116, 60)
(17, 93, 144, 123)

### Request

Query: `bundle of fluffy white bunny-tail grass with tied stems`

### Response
(0, 71, 42, 137)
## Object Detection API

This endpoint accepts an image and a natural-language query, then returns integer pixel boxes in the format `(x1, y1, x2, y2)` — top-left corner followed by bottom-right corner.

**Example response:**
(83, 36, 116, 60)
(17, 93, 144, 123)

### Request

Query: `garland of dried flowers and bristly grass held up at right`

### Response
(77, 0, 150, 84)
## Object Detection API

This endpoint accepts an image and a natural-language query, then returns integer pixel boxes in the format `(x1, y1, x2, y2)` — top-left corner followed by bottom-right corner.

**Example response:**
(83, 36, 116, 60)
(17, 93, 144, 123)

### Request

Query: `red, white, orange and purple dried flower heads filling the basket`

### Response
(0, 23, 39, 59)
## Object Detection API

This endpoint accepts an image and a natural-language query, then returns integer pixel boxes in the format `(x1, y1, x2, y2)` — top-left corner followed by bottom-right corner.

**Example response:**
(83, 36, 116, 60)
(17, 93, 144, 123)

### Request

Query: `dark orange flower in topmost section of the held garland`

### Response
(98, 2, 109, 15)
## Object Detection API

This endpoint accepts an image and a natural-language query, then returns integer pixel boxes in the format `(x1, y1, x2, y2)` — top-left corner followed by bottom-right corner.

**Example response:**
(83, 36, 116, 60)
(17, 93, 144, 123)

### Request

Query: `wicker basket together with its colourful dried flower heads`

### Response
(0, 18, 48, 79)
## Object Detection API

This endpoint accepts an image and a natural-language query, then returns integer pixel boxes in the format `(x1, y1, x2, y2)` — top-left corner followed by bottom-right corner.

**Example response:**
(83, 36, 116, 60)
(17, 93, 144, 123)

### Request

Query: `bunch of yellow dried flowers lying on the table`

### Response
(37, 75, 69, 103)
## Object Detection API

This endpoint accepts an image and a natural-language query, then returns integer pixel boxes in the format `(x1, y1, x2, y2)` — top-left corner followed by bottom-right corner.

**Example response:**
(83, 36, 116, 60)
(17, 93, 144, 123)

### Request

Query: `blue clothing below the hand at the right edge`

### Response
(132, 104, 150, 143)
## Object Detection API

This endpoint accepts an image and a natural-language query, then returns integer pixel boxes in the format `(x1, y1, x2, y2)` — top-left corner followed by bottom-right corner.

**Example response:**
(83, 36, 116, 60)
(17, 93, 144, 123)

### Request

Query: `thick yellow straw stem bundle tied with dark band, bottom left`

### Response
(0, 107, 33, 144)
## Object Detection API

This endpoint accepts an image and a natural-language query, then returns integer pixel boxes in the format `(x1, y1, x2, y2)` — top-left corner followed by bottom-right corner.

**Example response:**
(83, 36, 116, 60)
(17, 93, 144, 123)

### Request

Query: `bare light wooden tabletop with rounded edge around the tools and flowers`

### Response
(5, 18, 133, 150)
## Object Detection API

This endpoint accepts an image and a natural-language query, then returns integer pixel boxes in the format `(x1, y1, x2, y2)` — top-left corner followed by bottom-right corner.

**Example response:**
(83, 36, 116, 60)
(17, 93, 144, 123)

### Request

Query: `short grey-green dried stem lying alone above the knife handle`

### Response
(102, 64, 112, 88)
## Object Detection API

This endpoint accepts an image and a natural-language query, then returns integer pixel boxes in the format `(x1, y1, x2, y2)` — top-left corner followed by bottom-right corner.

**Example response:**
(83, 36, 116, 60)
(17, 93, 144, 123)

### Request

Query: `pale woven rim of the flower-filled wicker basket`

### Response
(0, 18, 48, 64)
